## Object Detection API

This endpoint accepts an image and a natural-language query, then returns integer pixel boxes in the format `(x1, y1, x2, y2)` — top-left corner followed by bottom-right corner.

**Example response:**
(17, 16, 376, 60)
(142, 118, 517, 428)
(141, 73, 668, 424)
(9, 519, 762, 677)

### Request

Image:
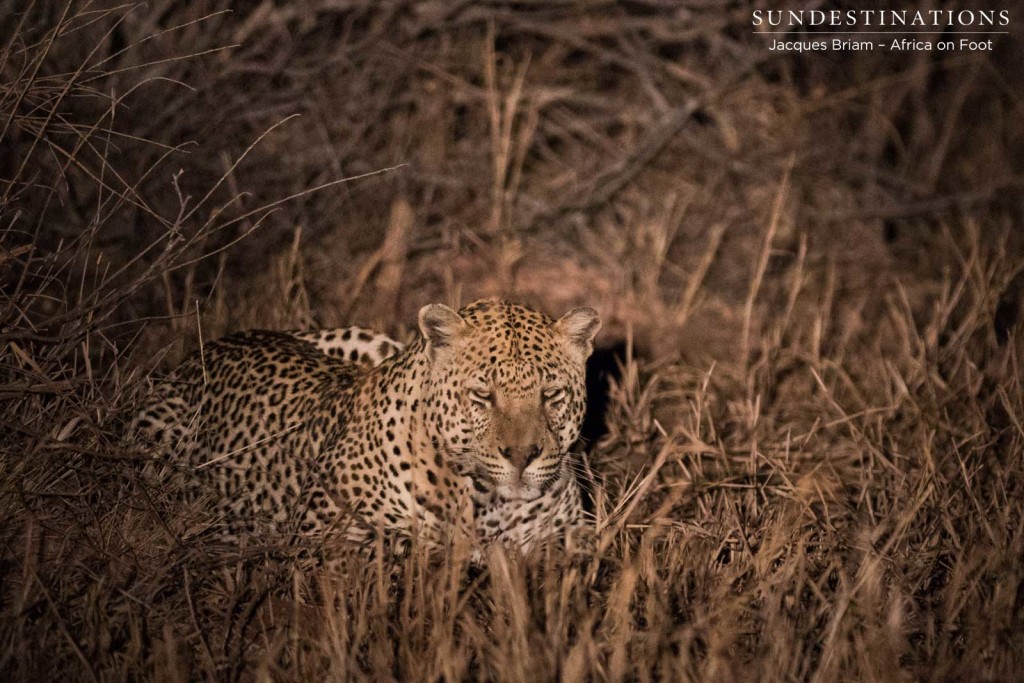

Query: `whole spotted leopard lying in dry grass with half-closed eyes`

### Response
(136, 300, 601, 551)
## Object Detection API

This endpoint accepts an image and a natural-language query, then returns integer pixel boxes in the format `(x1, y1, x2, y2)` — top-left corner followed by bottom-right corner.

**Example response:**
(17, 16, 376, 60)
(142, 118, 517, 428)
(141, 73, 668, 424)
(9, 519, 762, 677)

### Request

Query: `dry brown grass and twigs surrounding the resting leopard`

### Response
(0, 0, 1024, 681)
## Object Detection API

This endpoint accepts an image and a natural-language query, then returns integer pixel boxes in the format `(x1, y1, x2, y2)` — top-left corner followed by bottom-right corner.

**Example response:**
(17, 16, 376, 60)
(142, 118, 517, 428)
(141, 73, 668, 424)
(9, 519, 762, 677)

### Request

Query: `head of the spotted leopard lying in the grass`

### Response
(419, 301, 601, 500)
